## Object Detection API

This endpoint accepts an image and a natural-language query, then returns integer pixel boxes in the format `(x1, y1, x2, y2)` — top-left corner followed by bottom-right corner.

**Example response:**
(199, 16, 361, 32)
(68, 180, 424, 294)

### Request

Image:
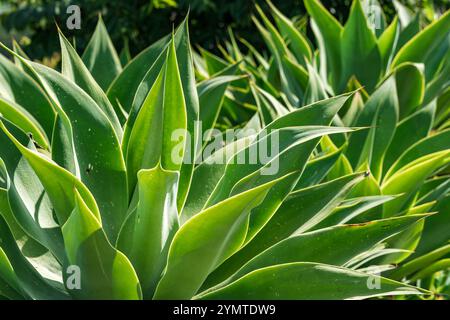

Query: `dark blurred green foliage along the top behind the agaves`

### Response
(0, 0, 449, 60)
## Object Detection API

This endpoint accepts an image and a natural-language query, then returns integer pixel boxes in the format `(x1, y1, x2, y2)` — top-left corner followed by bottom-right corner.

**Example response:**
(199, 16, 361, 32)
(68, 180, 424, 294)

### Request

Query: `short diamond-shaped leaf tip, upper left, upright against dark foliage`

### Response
(82, 16, 122, 91)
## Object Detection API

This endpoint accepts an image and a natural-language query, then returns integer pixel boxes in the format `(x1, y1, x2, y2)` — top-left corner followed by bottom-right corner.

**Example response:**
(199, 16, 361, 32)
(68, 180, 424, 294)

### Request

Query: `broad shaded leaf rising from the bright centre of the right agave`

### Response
(346, 77, 399, 180)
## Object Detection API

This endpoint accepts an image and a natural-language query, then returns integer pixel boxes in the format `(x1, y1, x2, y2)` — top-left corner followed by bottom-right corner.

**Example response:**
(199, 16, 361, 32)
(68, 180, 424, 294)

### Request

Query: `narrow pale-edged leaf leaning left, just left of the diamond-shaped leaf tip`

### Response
(58, 30, 122, 140)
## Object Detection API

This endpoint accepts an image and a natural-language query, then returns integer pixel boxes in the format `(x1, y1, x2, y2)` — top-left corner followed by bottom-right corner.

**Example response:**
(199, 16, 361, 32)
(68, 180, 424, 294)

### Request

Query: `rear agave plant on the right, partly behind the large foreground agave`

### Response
(204, 0, 450, 292)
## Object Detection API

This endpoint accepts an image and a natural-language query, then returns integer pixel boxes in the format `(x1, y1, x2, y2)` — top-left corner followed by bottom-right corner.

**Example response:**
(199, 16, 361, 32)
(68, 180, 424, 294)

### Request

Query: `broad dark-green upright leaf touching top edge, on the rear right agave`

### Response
(342, 0, 382, 92)
